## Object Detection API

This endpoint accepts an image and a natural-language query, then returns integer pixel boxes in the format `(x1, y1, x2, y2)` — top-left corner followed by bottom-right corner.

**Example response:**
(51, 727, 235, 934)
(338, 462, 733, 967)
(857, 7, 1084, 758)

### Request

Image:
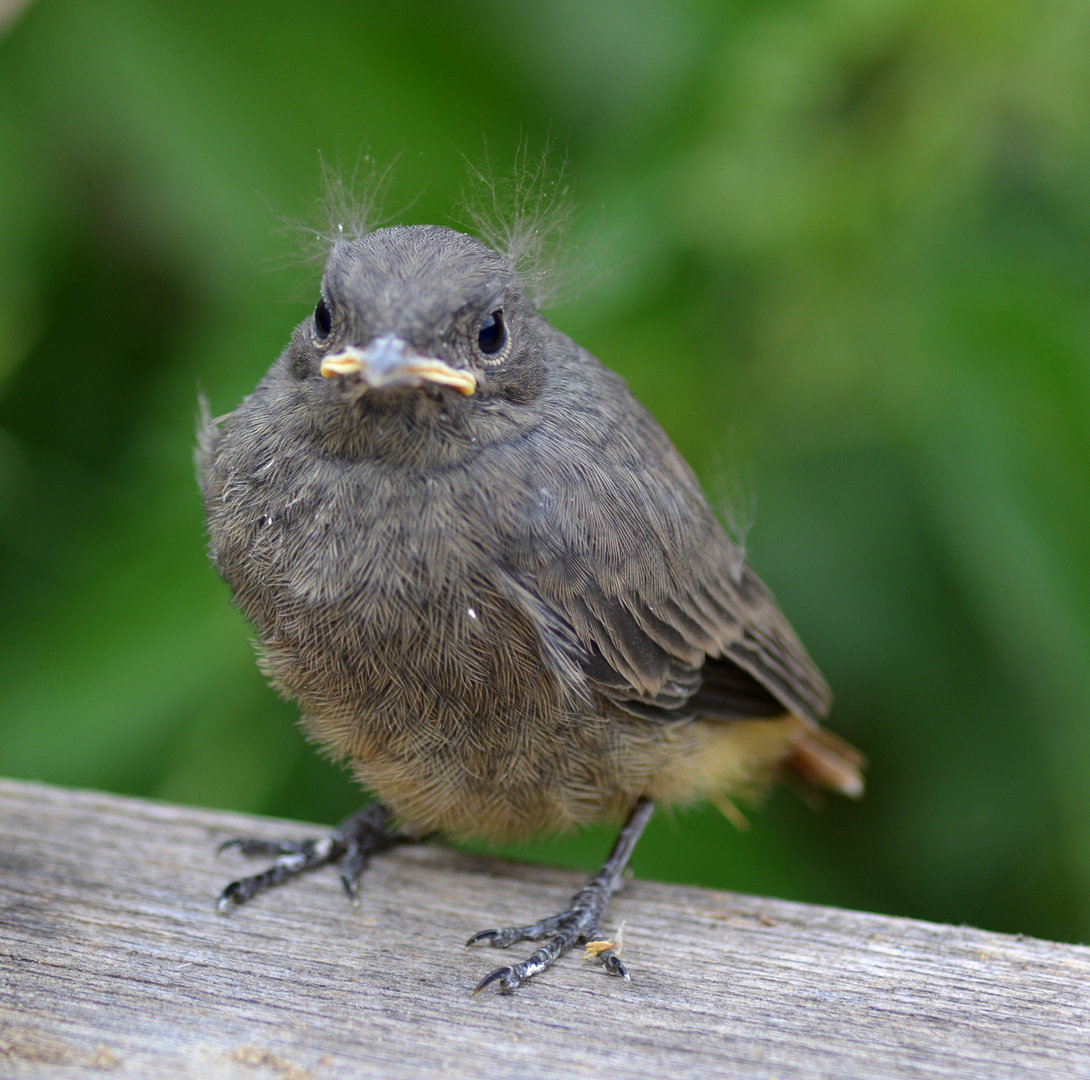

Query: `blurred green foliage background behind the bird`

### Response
(0, 0, 1090, 941)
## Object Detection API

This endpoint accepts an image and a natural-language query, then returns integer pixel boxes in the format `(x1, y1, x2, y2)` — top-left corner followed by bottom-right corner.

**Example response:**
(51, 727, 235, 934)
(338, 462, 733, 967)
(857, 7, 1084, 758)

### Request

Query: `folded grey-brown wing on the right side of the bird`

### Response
(504, 359, 831, 721)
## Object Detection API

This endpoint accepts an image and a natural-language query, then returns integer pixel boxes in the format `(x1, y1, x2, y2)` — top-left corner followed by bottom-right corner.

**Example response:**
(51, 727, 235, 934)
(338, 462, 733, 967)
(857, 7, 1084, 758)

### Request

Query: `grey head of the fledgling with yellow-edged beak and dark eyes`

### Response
(270, 226, 545, 462)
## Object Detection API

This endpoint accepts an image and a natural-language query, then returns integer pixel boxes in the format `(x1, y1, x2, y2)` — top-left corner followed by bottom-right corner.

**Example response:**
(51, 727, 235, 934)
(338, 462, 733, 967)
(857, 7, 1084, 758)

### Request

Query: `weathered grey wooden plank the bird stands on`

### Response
(0, 781, 1090, 1080)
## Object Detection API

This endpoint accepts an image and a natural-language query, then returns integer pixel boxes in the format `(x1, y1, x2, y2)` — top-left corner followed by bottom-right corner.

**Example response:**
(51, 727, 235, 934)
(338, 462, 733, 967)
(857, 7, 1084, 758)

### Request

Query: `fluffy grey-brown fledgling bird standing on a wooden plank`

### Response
(197, 225, 864, 994)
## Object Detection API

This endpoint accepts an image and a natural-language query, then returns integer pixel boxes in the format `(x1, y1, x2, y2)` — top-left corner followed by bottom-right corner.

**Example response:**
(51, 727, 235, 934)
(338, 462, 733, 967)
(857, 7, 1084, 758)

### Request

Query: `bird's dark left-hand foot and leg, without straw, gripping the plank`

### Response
(217, 802, 421, 911)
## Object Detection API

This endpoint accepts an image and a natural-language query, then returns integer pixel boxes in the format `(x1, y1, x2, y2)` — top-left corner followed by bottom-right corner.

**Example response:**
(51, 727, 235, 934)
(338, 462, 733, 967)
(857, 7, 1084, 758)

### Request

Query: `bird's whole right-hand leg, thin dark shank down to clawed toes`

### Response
(465, 799, 655, 996)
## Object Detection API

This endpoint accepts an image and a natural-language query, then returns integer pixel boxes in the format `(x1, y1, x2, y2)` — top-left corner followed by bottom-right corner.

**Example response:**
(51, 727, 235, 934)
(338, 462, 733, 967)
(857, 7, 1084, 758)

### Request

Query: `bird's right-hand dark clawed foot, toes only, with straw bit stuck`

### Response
(465, 874, 629, 997)
